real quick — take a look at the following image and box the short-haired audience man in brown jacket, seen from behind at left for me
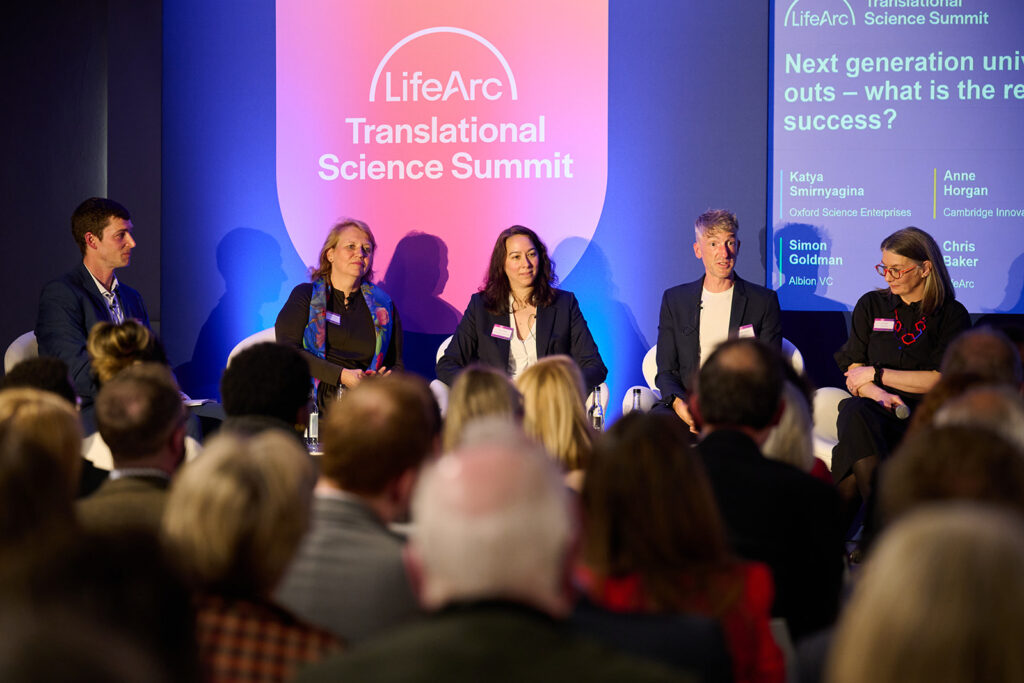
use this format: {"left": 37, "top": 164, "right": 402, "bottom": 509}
{"left": 77, "top": 362, "right": 185, "bottom": 533}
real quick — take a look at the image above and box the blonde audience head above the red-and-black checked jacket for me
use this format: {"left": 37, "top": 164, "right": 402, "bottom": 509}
{"left": 164, "top": 429, "right": 313, "bottom": 599}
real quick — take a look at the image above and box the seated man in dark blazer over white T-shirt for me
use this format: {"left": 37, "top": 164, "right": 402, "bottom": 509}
{"left": 654, "top": 209, "right": 782, "bottom": 429}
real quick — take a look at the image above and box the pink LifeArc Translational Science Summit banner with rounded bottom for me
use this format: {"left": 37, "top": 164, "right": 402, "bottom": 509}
{"left": 276, "top": 0, "right": 608, "bottom": 310}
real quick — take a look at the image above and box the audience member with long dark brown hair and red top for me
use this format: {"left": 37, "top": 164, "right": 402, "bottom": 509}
{"left": 577, "top": 411, "right": 785, "bottom": 683}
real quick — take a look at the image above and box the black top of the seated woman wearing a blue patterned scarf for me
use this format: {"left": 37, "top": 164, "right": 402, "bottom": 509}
{"left": 274, "top": 283, "right": 401, "bottom": 386}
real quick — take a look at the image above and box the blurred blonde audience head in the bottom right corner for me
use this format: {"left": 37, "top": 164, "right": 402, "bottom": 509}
{"left": 826, "top": 505, "right": 1024, "bottom": 683}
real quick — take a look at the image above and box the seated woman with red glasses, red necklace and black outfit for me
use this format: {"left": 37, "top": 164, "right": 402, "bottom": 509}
{"left": 831, "top": 227, "right": 971, "bottom": 532}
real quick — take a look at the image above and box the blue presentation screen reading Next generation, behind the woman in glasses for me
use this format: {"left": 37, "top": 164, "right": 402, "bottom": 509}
{"left": 766, "top": 0, "right": 1024, "bottom": 313}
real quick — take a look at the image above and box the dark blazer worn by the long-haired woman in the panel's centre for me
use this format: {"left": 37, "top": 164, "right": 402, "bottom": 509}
{"left": 437, "top": 290, "right": 608, "bottom": 389}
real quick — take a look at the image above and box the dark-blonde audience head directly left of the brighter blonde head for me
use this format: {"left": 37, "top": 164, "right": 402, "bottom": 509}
{"left": 442, "top": 364, "right": 523, "bottom": 451}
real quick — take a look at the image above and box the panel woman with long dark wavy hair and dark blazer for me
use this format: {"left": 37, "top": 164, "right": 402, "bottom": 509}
{"left": 437, "top": 225, "right": 608, "bottom": 389}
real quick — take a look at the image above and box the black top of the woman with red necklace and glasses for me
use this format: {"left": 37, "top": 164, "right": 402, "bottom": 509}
{"left": 836, "top": 290, "right": 971, "bottom": 401}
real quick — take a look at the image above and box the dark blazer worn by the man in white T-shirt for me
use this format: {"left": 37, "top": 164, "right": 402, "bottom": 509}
{"left": 654, "top": 276, "right": 782, "bottom": 405}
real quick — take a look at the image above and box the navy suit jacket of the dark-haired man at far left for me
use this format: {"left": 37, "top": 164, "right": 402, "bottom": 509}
{"left": 36, "top": 263, "right": 150, "bottom": 409}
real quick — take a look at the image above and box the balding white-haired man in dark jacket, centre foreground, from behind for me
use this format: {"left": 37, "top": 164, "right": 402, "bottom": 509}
{"left": 300, "top": 420, "right": 682, "bottom": 682}
